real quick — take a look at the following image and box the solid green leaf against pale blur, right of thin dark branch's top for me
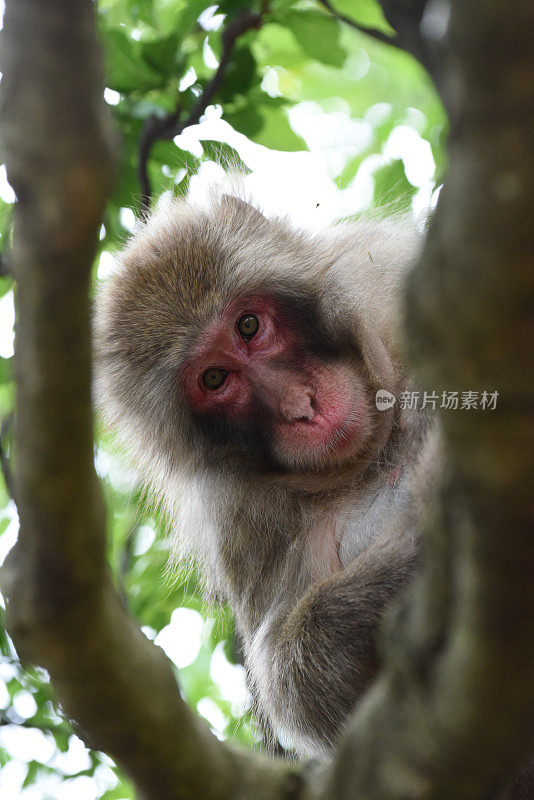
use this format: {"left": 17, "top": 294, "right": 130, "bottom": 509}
{"left": 282, "top": 10, "right": 347, "bottom": 67}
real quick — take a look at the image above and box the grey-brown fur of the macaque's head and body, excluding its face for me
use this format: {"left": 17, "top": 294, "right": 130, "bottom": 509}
{"left": 95, "top": 193, "right": 439, "bottom": 755}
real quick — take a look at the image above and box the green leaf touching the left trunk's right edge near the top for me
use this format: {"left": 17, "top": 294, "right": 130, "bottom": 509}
{"left": 102, "top": 28, "right": 164, "bottom": 93}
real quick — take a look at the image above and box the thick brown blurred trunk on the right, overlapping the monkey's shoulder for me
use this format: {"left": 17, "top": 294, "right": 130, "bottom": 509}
{"left": 322, "top": 0, "right": 534, "bottom": 800}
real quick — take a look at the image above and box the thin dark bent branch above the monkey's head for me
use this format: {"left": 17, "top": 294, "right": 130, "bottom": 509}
{"left": 138, "top": 9, "right": 262, "bottom": 213}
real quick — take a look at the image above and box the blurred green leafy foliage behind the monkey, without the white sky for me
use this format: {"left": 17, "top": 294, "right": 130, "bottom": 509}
{"left": 0, "top": 0, "right": 445, "bottom": 800}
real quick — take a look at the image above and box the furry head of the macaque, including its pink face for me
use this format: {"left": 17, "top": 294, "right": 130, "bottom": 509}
{"left": 95, "top": 196, "right": 406, "bottom": 489}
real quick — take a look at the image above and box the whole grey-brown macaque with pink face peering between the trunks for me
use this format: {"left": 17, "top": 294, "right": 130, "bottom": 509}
{"left": 95, "top": 192, "right": 439, "bottom": 756}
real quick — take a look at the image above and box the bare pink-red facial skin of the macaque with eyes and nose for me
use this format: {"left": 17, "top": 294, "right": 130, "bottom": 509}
{"left": 184, "top": 296, "right": 372, "bottom": 468}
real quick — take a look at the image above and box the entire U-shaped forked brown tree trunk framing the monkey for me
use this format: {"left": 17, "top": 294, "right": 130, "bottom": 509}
{"left": 1, "top": 0, "right": 534, "bottom": 800}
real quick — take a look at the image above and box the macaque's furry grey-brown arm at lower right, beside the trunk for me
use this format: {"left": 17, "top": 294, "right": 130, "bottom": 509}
{"left": 264, "top": 537, "right": 417, "bottom": 755}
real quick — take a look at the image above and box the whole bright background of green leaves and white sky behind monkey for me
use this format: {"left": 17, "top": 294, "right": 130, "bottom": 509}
{"left": 0, "top": 0, "right": 446, "bottom": 800}
